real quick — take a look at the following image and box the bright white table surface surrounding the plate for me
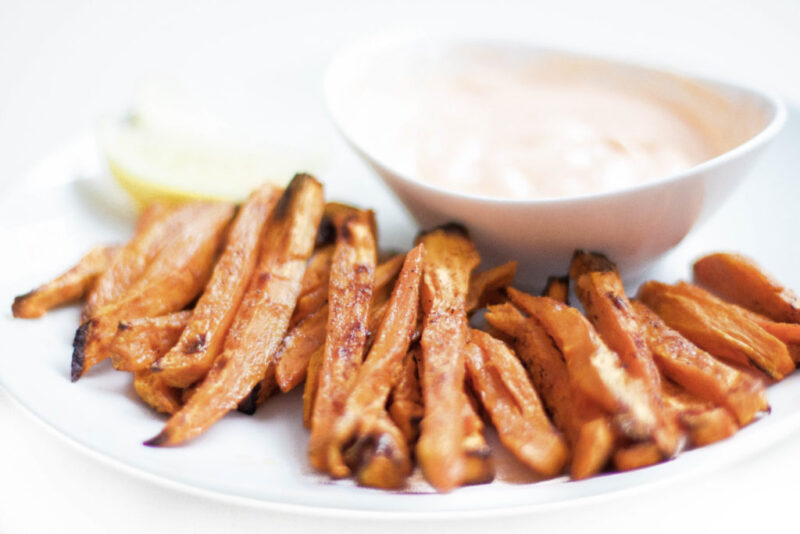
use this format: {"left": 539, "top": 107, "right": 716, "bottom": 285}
{"left": 0, "top": 0, "right": 800, "bottom": 534}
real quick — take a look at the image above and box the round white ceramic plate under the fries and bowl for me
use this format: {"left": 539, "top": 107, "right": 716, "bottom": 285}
{"left": 0, "top": 105, "right": 800, "bottom": 518}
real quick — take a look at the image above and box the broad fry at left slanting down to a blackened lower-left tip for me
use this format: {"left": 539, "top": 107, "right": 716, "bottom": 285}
{"left": 72, "top": 203, "right": 233, "bottom": 381}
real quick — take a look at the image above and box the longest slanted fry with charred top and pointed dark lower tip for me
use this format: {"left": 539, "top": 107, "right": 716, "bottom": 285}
{"left": 146, "top": 174, "right": 323, "bottom": 446}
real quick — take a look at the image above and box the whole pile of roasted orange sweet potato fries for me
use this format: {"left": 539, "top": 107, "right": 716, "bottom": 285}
{"left": 13, "top": 175, "right": 800, "bottom": 491}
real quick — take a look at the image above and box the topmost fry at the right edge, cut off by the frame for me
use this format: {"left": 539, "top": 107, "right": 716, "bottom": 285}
{"left": 694, "top": 253, "right": 800, "bottom": 323}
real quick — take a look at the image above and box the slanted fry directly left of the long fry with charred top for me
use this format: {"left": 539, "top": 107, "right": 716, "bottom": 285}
{"left": 153, "top": 185, "right": 281, "bottom": 388}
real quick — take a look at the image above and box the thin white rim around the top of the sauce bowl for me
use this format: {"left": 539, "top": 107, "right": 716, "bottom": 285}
{"left": 323, "top": 30, "right": 787, "bottom": 206}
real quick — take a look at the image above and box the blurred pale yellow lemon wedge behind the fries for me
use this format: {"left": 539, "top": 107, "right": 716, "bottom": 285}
{"left": 97, "top": 82, "right": 326, "bottom": 205}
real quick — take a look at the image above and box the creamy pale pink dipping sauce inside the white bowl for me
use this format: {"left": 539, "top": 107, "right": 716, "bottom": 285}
{"left": 346, "top": 49, "right": 722, "bottom": 198}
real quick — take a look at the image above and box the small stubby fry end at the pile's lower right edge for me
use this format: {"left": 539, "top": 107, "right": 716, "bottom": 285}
{"left": 664, "top": 381, "right": 739, "bottom": 447}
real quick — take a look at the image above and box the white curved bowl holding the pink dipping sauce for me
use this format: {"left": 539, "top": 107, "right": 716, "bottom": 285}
{"left": 325, "top": 34, "right": 786, "bottom": 286}
